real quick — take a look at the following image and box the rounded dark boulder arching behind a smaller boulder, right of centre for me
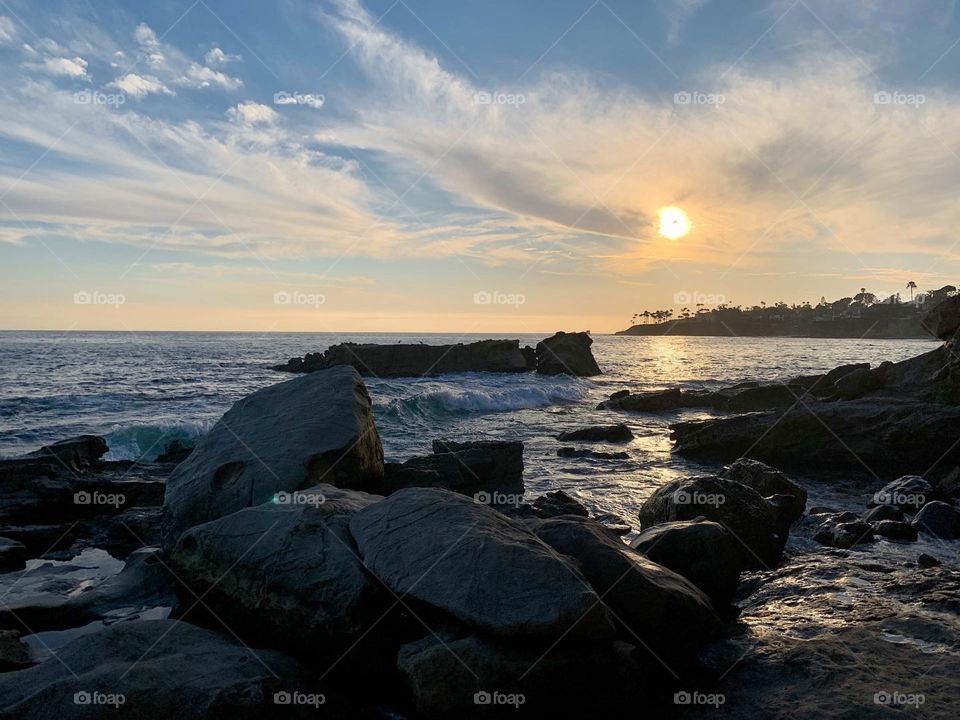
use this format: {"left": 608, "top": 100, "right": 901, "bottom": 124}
{"left": 639, "top": 476, "right": 787, "bottom": 569}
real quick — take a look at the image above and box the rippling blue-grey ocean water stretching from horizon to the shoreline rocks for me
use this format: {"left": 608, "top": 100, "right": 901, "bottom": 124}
{"left": 0, "top": 332, "right": 936, "bottom": 520}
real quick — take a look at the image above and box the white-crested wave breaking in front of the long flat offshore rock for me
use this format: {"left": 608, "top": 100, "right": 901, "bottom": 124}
{"left": 384, "top": 385, "right": 586, "bottom": 417}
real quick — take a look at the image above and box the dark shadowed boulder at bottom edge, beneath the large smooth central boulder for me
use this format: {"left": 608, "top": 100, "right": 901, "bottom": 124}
{"left": 397, "top": 635, "right": 647, "bottom": 720}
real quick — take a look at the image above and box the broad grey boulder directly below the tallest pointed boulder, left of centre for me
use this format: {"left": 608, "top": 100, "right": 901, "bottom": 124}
{"left": 171, "top": 485, "right": 390, "bottom": 666}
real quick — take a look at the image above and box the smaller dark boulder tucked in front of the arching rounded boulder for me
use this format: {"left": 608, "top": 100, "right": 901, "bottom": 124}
{"left": 630, "top": 520, "right": 740, "bottom": 613}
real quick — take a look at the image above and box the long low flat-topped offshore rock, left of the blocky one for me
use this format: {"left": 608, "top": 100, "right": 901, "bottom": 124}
{"left": 273, "top": 340, "right": 528, "bottom": 377}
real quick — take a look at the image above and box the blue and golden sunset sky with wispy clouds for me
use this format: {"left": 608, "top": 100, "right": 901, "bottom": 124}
{"left": 0, "top": 0, "right": 960, "bottom": 334}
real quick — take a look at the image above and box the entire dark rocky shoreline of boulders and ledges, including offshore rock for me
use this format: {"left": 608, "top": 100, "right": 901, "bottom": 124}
{"left": 0, "top": 304, "right": 960, "bottom": 719}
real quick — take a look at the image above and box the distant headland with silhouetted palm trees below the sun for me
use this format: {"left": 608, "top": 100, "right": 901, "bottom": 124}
{"left": 616, "top": 281, "right": 957, "bottom": 338}
